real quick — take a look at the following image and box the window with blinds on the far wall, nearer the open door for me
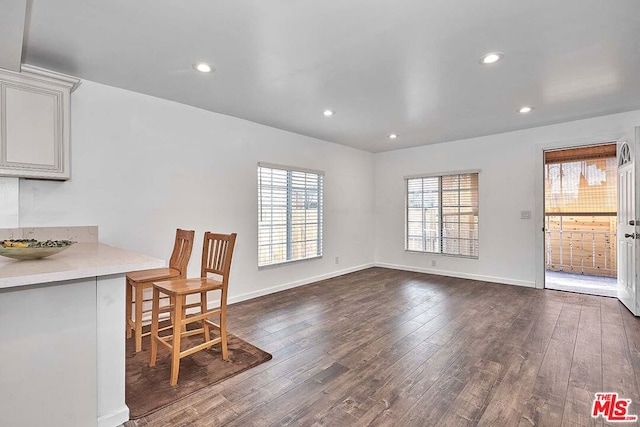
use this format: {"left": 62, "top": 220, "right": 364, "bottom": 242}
{"left": 405, "top": 173, "right": 478, "bottom": 258}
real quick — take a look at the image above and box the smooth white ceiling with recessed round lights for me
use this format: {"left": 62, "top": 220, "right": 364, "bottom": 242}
{"left": 13, "top": 0, "right": 640, "bottom": 152}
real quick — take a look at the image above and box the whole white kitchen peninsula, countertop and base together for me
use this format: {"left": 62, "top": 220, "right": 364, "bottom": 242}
{"left": 0, "top": 242, "right": 166, "bottom": 427}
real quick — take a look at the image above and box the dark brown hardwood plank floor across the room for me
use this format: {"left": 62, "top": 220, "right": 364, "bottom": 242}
{"left": 126, "top": 268, "right": 640, "bottom": 427}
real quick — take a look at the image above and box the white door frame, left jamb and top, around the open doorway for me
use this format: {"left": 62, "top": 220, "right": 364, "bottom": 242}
{"left": 533, "top": 132, "right": 629, "bottom": 289}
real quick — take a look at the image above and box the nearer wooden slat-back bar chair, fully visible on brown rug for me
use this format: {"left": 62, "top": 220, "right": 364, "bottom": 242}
{"left": 149, "top": 231, "right": 236, "bottom": 385}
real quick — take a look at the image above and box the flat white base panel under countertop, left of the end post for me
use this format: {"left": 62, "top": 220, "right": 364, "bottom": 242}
{"left": 0, "top": 277, "right": 98, "bottom": 427}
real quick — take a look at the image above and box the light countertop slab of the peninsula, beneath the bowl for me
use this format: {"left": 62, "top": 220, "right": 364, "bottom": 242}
{"left": 0, "top": 243, "right": 166, "bottom": 289}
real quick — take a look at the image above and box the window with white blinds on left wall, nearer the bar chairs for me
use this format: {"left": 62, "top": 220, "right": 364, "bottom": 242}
{"left": 258, "top": 163, "right": 324, "bottom": 267}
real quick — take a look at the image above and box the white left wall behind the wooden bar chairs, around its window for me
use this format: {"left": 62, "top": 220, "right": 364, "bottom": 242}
{"left": 19, "top": 81, "right": 374, "bottom": 301}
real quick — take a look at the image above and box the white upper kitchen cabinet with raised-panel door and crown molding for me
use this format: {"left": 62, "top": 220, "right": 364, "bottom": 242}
{"left": 0, "top": 65, "right": 79, "bottom": 179}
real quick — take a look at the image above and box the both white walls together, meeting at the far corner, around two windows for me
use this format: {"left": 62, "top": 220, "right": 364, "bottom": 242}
{"left": 8, "top": 77, "right": 640, "bottom": 301}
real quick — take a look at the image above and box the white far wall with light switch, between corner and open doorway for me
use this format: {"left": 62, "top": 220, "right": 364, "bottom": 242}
{"left": 375, "top": 111, "right": 640, "bottom": 286}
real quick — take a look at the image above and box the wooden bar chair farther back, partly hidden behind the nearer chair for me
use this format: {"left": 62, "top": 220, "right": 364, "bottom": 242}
{"left": 125, "top": 228, "right": 195, "bottom": 352}
